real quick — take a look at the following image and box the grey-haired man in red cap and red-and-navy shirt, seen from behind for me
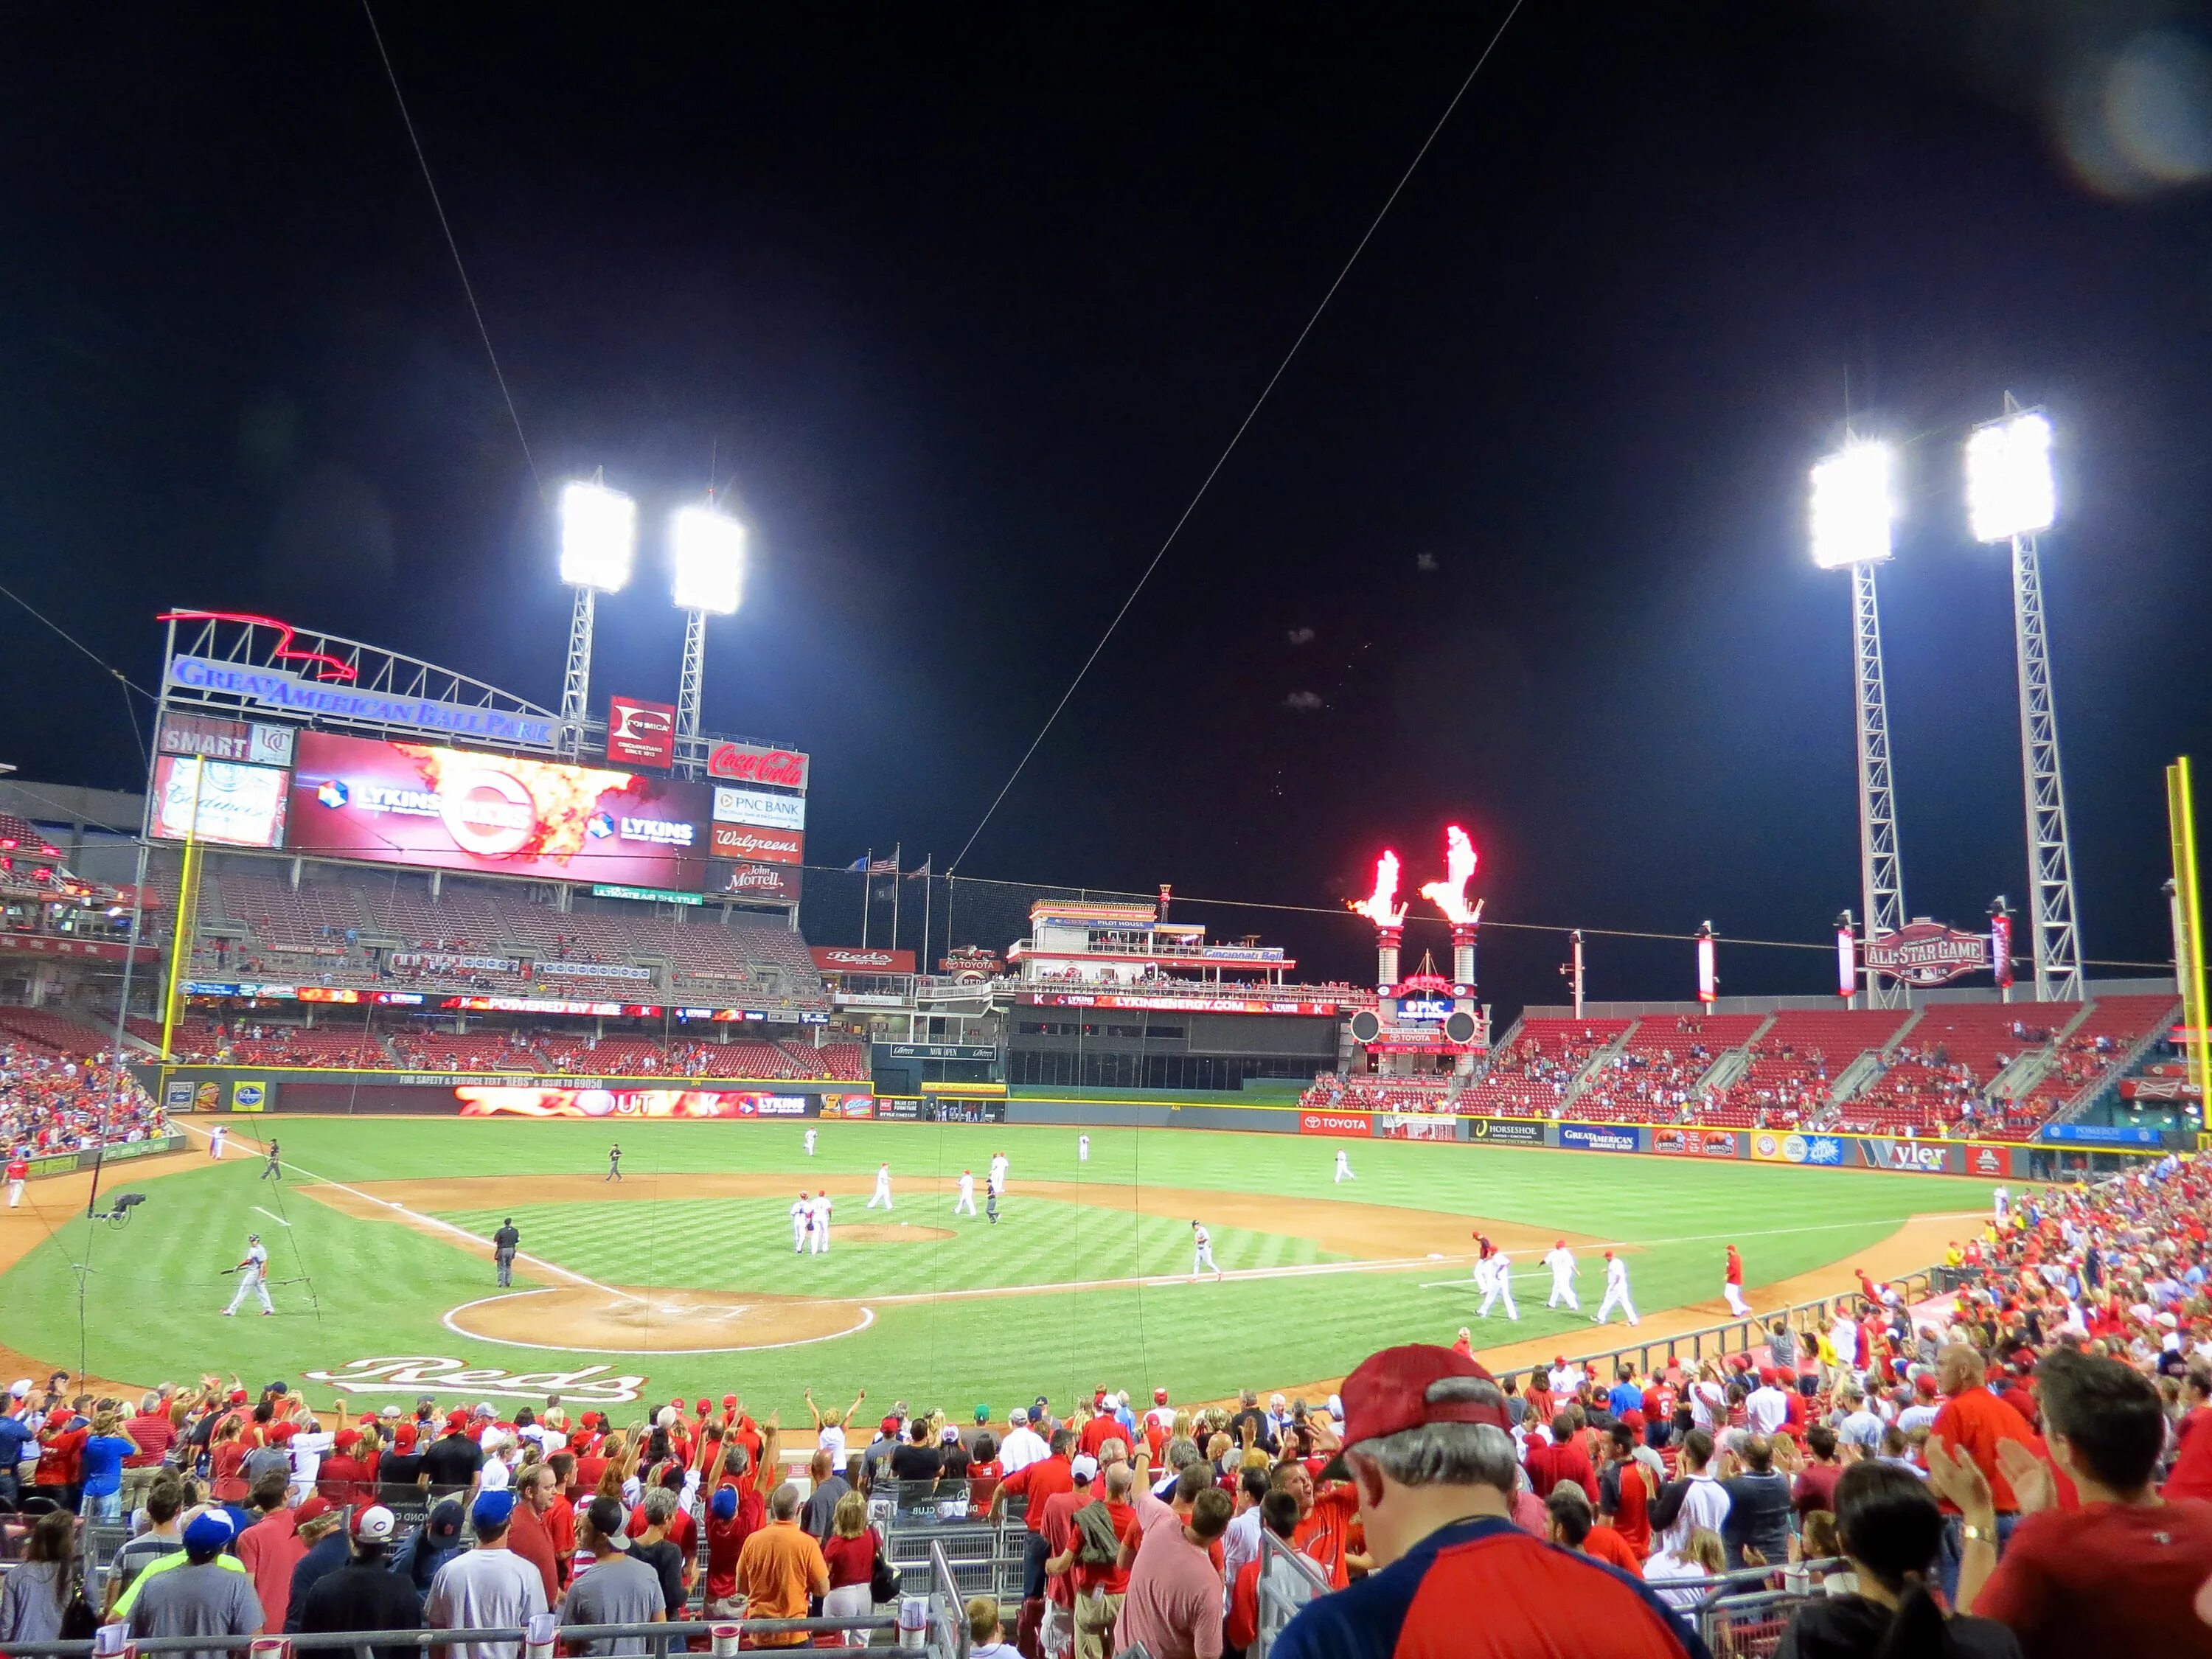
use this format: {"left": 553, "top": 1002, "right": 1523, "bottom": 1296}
{"left": 1274, "top": 1343, "right": 1710, "bottom": 1659}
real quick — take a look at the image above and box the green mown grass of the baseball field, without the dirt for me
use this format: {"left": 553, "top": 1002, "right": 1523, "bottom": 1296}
{"left": 0, "top": 1119, "right": 1989, "bottom": 1418}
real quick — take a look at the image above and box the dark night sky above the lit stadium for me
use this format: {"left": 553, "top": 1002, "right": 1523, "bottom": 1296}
{"left": 0, "top": 0, "right": 2212, "bottom": 1006}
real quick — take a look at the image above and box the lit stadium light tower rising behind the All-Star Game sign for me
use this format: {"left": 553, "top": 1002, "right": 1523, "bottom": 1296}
{"left": 1812, "top": 438, "right": 1905, "bottom": 1009}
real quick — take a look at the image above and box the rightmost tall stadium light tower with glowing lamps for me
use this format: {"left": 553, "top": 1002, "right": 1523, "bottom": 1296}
{"left": 1966, "top": 394, "right": 2081, "bottom": 1002}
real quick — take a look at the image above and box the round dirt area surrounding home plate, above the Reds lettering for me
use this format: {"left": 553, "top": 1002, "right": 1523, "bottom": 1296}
{"left": 445, "top": 1285, "right": 876, "bottom": 1354}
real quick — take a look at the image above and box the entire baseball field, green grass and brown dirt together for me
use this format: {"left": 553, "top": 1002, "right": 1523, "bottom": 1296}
{"left": 0, "top": 1117, "right": 1989, "bottom": 1422}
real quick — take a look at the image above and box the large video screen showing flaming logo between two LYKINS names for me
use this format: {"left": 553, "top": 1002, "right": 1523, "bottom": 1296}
{"left": 290, "top": 732, "right": 708, "bottom": 889}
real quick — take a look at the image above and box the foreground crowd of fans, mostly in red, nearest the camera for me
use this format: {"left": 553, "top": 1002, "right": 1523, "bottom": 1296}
{"left": 13, "top": 1159, "right": 2212, "bottom": 1659}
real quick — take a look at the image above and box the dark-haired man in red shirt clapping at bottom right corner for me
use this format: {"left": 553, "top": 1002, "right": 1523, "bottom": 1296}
{"left": 1929, "top": 1349, "right": 2212, "bottom": 1659}
